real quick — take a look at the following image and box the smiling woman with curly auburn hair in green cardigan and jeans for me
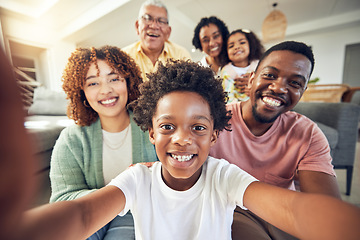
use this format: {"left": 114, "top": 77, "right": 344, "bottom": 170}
{"left": 50, "top": 46, "right": 156, "bottom": 239}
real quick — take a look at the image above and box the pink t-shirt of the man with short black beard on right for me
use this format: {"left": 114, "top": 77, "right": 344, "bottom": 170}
{"left": 210, "top": 103, "right": 335, "bottom": 189}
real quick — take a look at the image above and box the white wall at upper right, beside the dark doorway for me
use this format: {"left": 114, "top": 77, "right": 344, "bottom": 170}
{"left": 266, "top": 23, "right": 360, "bottom": 85}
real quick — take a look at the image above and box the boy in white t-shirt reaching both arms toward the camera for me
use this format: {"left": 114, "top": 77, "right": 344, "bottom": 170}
{"left": 22, "top": 61, "right": 360, "bottom": 239}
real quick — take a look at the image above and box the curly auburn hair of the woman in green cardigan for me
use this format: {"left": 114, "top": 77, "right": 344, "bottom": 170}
{"left": 62, "top": 46, "right": 143, "bottom": 126}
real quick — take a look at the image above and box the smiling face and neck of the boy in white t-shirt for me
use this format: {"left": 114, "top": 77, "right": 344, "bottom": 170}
{"left": 149, "top": 91, "right": 218, "bottom": 191}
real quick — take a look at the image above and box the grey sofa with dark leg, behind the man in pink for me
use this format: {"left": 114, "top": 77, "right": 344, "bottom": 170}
{"left": 293, "top": 102, "right": 360, "bottom": 195}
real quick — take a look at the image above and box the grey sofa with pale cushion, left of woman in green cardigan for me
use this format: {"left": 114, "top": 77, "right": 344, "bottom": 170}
{"left": 24, "top": 87, "right": 74, "bottom": 206}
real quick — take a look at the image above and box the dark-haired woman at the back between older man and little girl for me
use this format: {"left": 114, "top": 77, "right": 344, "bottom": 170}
{"left": 192, "top": 16, "right": 229, "bottom": 75}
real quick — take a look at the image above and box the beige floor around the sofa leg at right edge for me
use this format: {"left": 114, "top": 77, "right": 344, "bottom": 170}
{"left": 335, "top": 137, "right": 360, "bottom": 207}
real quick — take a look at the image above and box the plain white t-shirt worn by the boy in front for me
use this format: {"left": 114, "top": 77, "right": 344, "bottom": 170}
{"left": 109, "top": 157, "right": 256, "bottom": 240}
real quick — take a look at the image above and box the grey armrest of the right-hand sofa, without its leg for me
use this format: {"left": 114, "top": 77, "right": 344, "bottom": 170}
{"left": 294, "top": 102, "right": 360, "bottom": 166}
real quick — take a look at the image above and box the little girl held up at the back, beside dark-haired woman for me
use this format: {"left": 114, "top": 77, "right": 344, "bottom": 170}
{"left": 221, "top": 29, "right": 264, "bottom": 103}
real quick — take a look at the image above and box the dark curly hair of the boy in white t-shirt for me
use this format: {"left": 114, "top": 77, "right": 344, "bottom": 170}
{"left": 131, "top": 60, "right": 231, "bottom": 131}
